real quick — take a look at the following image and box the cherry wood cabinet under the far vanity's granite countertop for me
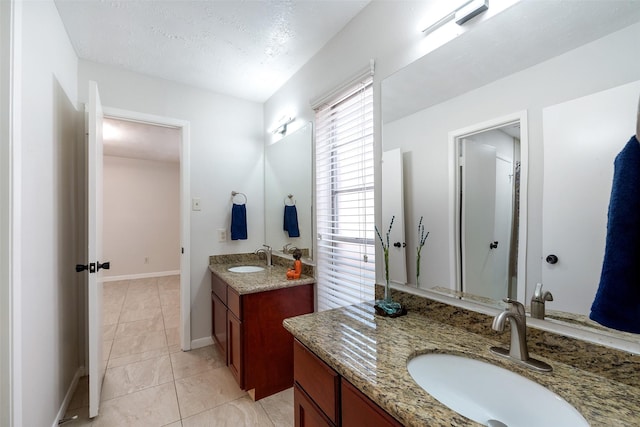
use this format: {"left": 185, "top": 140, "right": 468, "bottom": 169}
{"left": 211, "top": 272, "right": 314, "bottom": 400}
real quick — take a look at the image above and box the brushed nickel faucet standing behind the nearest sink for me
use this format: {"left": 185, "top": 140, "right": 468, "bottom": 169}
{"left": 490, "top": 298, "right": 551, "bottom": 372}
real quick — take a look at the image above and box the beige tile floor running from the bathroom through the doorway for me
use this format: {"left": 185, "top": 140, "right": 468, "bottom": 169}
{"left": 64, "top": 276, "right": 293, "bottom": 427}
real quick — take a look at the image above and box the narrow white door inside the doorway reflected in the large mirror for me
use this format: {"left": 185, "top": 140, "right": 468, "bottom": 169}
{"left": 460, "top": 139, "right": 500, "bottom": 299}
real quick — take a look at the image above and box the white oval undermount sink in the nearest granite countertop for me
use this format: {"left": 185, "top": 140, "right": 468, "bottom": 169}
{"left": 407, "top": 353, "right": 589, "bottom": 427}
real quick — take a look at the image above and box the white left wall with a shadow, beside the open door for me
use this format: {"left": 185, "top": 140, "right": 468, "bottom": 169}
{"left": 19, "top": 1, "right": 82, "bottom": 426}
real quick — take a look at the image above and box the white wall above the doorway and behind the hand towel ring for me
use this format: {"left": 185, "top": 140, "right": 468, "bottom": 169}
{"left": 78, "top": 60, "right": 264, "bottom": 340}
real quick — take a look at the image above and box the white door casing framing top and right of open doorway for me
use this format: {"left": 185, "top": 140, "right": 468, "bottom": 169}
{"left": 103, "top": 107, "right": 192, "bottom": 351}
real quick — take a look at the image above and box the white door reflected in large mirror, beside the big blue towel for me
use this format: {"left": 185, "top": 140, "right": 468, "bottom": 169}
{"left": 541, "top": 81, "right": 640, "bottom": 315}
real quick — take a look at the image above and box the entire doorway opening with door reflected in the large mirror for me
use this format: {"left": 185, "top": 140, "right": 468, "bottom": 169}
{"left": 458, "top": 124, "right": 520, "bottom": 300}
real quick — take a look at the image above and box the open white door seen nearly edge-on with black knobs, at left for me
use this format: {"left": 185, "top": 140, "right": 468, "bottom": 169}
{"left": 87, "top": 82, "right": 109, "bottom": 418}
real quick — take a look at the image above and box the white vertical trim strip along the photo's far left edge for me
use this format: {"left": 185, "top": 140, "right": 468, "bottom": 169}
{"left": 0, "top": 0, "right": 22, "bottom": 427}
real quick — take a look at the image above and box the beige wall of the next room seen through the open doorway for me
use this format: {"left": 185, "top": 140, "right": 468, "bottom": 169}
{"left": 103, "top": 155, "right": 180, "bottom": 277}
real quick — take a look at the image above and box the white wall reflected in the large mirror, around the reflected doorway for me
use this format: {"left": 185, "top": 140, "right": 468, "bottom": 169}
{"left": 384, "top": 20, "right": 640, "bottom": 300}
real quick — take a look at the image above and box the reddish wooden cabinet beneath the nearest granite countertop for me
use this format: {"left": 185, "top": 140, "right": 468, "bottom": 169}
{"left": 293, "top": 340, "right": 402, "bottom": 427}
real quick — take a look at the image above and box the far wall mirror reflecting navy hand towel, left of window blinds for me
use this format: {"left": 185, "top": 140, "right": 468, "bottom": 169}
{"left": 264, "top": 122, "right": 313, "bottom": 257}
